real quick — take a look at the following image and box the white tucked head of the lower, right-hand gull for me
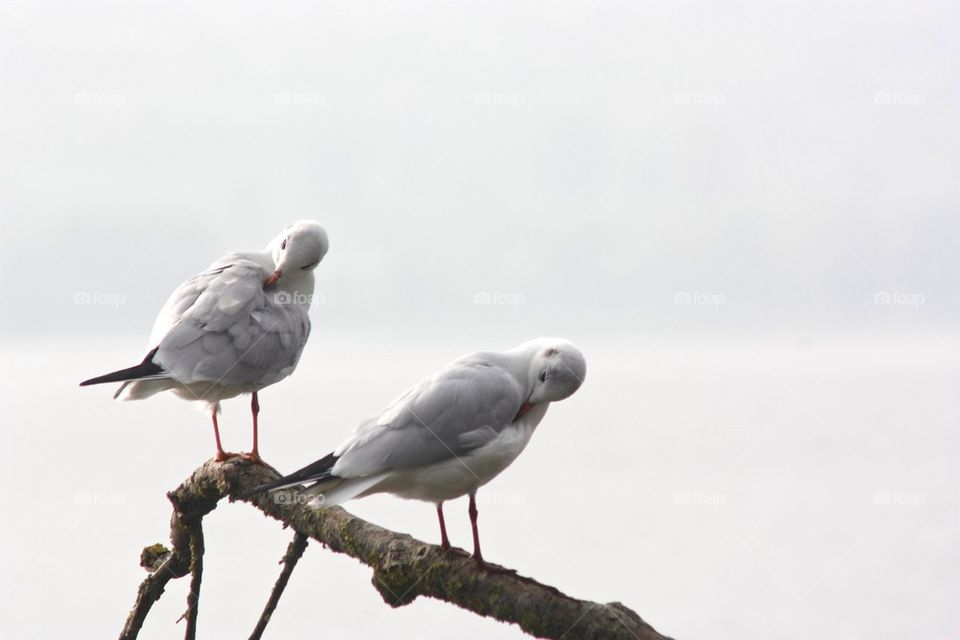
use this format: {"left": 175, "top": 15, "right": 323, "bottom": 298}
{"left": 524, "top": 338, "right": 587, "bottom": 404}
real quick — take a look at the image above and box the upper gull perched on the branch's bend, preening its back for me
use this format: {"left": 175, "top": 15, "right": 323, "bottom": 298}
{"left": 80, "top": 220, "right": 329, "bottom": 462}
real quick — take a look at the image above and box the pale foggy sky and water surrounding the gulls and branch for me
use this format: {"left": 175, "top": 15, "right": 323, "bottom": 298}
{"left": 0, "top": 1, "right": 960, "bottom": 639}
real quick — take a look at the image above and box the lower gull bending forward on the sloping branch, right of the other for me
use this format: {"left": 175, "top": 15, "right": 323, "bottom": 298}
{"left": 249, "top": 338, "right": 586, "bottom": 566}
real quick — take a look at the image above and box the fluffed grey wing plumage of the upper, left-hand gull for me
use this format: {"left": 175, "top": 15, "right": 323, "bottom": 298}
{"left": 151, "top": 254, "right": 310, "bottom": 388}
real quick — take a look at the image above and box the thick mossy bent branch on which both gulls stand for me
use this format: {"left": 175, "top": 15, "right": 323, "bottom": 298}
{"left": 120, "top": 459, "right": 668, "bottom": 640}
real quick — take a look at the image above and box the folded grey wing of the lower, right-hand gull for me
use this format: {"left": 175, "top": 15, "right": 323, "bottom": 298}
{"left": 333, "top": 362, "right": 525, "bottom": 477}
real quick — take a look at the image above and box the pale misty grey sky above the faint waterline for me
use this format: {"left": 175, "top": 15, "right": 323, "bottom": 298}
{"left": 0, "top": 2, "right": 960, "bottom": 344}
